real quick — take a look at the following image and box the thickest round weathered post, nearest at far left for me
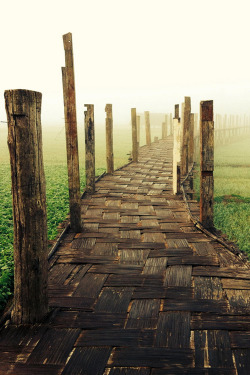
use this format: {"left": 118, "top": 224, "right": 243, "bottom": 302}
{"left": 5, "top": 90, "right": 48, "bottom": 324}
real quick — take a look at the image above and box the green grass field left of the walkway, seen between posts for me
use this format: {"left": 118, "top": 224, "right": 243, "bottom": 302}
{"left": 0, "top": 126, "right": 131, "bottom": 311}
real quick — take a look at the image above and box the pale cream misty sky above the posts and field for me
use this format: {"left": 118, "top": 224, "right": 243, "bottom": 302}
{"left": 0, "top": 0, "right": 250, "bottom": 126}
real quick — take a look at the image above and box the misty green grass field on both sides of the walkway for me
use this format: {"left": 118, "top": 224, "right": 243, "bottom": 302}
{"left": 0, "top": 124, "right": 250, "bottom": 310}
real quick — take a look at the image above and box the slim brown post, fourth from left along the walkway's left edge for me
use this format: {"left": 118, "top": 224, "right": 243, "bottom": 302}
{"left": 105, "top": 104, "right": 114, "bottom": 174}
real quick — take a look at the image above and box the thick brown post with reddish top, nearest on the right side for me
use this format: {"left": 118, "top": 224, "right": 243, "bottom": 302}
{"left": 200, "top": 100, "right": 214, "bottom": 229}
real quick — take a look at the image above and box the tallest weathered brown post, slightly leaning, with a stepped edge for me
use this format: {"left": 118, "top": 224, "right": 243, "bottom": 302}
{"left": 62, "top": 33, "right": 82, "bottom": 232}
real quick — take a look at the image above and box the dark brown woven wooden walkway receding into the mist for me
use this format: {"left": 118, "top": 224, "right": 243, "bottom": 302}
{"left": 0, "top": 139, "right": 250, "bottom": 375}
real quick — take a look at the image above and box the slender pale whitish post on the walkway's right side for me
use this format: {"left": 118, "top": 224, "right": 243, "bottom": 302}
{"left": 173, "top": 104, "right": 181, "bottom": 194}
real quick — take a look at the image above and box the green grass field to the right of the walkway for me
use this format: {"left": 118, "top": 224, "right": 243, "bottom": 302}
{"left": 195, "top": 138, "right": 250, "bottom": 258}
